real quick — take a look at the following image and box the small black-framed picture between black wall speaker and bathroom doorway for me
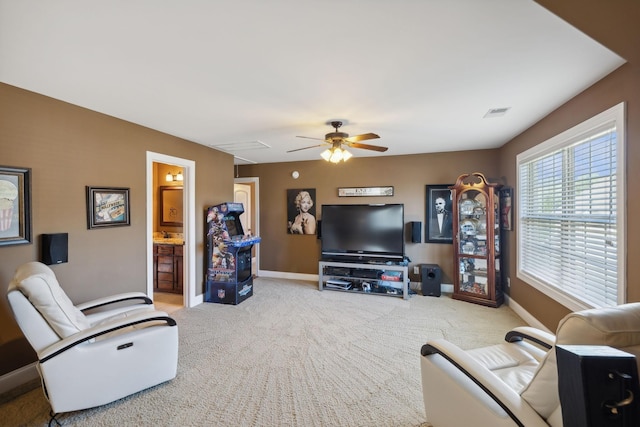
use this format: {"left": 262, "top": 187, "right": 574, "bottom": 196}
{"left": 87, "top": 187, "right": 131, "bottom": 229}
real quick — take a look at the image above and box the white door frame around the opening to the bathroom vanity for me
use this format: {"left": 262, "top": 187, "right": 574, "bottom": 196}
{"left": 146, "top": 151, "right": 203, "bottom": 307}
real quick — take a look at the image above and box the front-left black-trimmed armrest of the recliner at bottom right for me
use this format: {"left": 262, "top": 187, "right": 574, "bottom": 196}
{"left": 420, "top": 339, "right": 547, "bottom": 427}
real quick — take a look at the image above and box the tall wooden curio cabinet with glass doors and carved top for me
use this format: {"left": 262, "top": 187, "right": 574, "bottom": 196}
{"left": 451, "top": 172, "right": 504, "bottom": 307}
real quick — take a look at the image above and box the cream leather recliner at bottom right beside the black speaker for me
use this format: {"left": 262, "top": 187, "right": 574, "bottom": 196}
{"left": 421, "top": 303, "right": 640, "bottom": 427}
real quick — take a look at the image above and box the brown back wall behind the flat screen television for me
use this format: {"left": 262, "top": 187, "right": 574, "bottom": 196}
{"left": 239, "top": 150, "right": 501, "bottom": 283}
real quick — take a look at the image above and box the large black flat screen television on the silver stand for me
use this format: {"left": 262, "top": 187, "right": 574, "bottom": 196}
{"left": 320, "top": 204, "right": 404, "bottom": 262}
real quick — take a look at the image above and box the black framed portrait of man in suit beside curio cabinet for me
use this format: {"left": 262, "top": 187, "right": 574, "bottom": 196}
{"left": 425, "top": 184, "right": 453, "bottom": 243}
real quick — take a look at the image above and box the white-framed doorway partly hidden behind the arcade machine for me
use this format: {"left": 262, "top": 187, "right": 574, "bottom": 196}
{"left": 233, "top": 177, "right": 260, "bottom": 276}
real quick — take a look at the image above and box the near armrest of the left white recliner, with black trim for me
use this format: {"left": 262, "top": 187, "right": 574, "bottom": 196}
{"left": 38, "top": 311, "right": 177, "bottom": 363}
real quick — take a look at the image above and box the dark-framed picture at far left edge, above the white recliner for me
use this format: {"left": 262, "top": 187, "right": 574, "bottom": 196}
{"left": 0, "top": 166, "right": 31, "bottom": 246}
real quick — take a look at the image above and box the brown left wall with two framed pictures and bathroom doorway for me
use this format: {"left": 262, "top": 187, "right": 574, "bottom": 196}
{"left": 0, "top": 84, "right": 233, "bottom": 375}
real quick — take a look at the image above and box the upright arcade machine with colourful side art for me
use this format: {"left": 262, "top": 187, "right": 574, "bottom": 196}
{"left": 204, "top": 202, "right": 260, "bottom": 305}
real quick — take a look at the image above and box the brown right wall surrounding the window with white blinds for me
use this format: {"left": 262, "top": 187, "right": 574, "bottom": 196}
{"left": 490, "top": 0, "right": 640, "bottom": 330}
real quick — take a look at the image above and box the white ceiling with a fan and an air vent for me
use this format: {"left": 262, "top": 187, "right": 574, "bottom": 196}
{"left": 0, "top": 0, "right": 624, "bottom": 164}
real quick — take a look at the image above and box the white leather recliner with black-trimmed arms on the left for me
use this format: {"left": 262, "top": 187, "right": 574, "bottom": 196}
{"left": 7, "top": 262, "right": 178, "bottom": 418}
